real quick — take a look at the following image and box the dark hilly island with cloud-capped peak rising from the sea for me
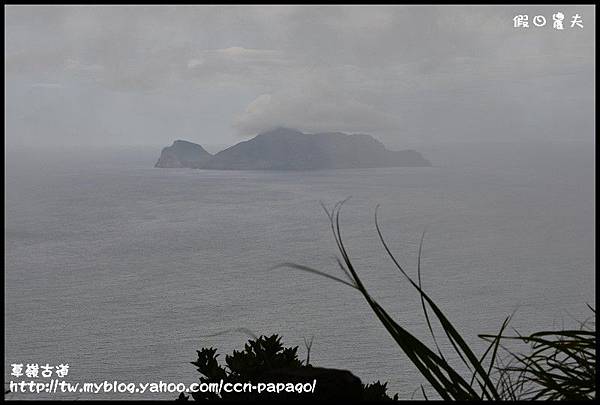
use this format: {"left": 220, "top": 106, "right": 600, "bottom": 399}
{"left": 156, "top": 128, "right": 431, "bottom": 170}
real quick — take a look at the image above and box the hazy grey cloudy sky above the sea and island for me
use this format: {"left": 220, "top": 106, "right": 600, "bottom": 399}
{"left": 5, "top": 5, "right": 595, "bottom": 146}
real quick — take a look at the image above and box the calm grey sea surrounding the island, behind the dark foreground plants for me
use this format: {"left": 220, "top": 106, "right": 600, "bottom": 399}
{"left": 4, "top": 143, "right": 596, "bottom": 399}
